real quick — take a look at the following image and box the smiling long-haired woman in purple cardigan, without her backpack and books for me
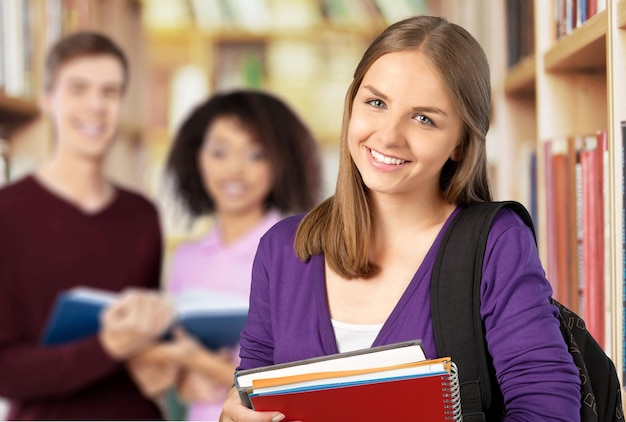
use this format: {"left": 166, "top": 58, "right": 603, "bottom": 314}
{"left": 221, "top": 16, "right": 580, "bottom": 422}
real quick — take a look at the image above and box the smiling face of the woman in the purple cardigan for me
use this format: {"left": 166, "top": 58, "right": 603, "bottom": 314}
{"left": 347, "top": 51, "right": 462, "bottom": 201}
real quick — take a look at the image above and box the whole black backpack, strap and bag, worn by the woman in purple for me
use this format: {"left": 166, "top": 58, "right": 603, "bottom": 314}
{"left": 431, "top": 201, "right": 624, "bottom": 422}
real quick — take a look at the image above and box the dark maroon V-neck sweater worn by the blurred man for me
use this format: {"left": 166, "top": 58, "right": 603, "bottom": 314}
{"left": 0, "top": 176, "right": 162, "bottom": 420}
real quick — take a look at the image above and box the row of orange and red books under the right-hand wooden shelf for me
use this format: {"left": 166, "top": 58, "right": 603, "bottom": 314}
{"left": 544, "top": 130, "right": 610, "bottom": 347}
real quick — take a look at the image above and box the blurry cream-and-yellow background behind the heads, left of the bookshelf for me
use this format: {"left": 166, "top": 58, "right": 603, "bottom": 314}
{"left": 0, "top": 0, "right": 504, "bottom": 250}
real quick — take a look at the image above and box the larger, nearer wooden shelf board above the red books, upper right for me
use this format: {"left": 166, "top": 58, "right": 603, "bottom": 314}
{"left": 544, "top": 9, "right": 604, "bottom": 72}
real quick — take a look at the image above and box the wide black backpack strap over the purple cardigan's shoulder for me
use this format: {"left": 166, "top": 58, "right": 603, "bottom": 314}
{"left": 430, "top": 201, "right": 534, "bottom": 421}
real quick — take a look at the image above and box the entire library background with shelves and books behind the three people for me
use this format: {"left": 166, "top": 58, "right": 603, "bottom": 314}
{"left": 0, "top": 0, "right": 626, "bottom": 413}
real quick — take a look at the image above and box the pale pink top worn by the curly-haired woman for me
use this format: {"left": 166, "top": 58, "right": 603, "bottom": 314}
{"left": 167, "top": 210, "right": 282, "bottom": 421}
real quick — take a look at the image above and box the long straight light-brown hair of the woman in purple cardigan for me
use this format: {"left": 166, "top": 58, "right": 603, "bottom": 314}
{"left": 294, "top": 16, "right": 491, "bottom": 278}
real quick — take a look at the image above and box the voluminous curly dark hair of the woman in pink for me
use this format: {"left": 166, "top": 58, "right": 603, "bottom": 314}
{"left": 165, "top": 90, "right": 322, "bottom": 218}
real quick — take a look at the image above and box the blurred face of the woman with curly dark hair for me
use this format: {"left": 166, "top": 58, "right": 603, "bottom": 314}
{"left": 198, "top": 116, "right": 273, "bottom": 216}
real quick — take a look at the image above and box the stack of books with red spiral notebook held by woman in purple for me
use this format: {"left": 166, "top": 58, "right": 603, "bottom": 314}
{"left": 235, "top": 340, "right": 461, "bottom": 422}
